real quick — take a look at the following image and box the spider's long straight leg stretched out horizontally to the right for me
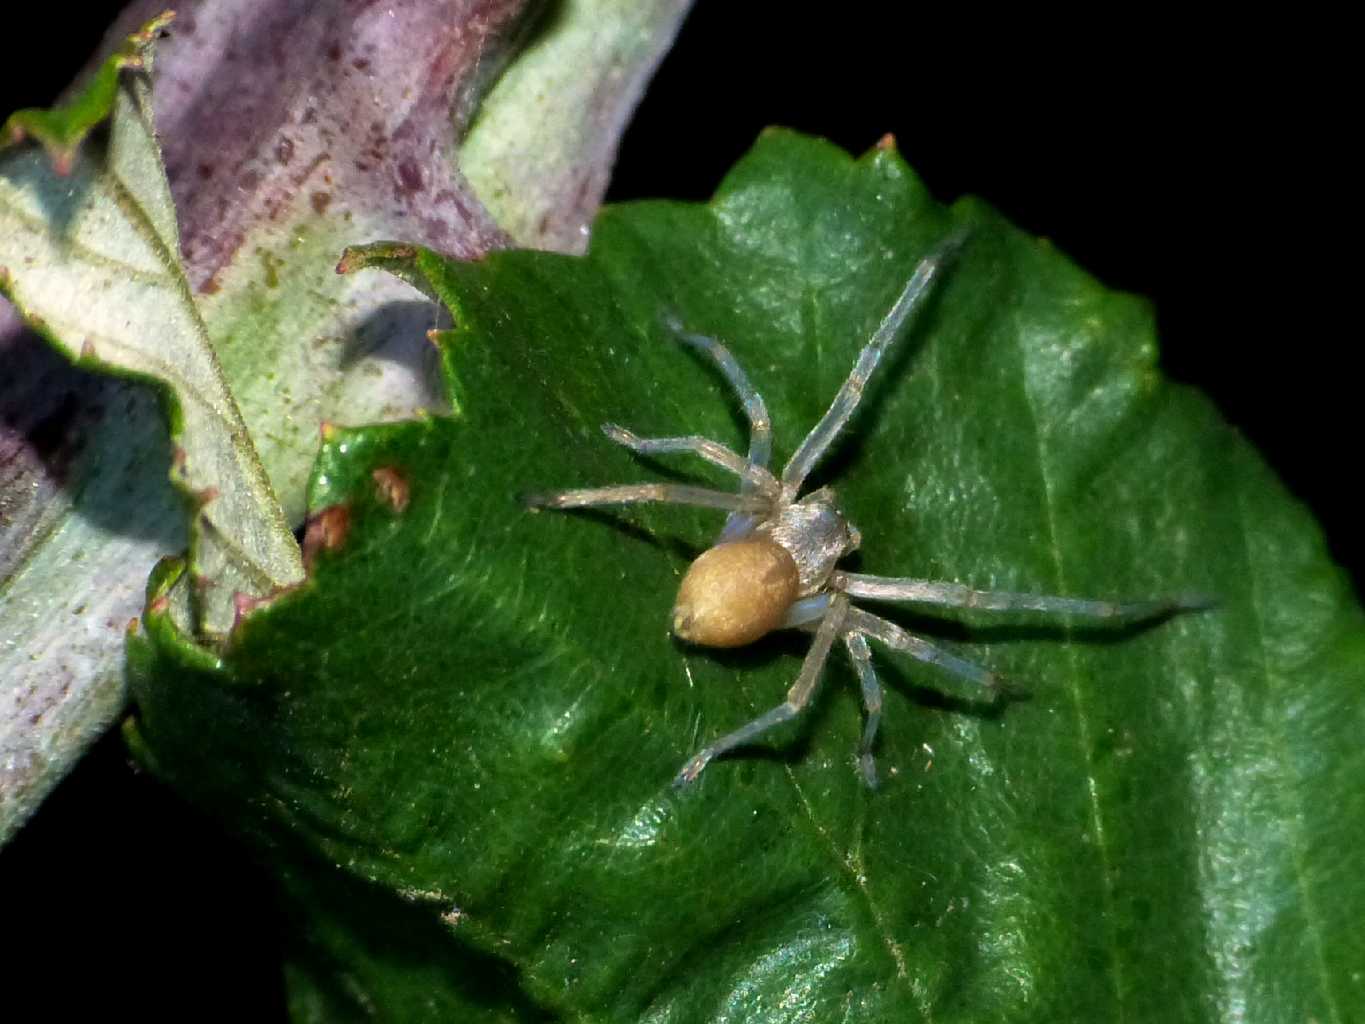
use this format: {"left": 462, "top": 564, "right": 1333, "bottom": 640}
{"left": 830, "top": 572, "right": 1212, "bottom": 624}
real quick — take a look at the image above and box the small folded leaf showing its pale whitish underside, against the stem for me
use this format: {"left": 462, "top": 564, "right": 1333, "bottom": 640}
{"left": 0, "top": 15, "right": 303, "bottom": 638}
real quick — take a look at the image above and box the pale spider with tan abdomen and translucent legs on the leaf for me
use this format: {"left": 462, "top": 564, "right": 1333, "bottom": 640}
{"left": 524, "top": 235, "right": 1207, "bottom": 788}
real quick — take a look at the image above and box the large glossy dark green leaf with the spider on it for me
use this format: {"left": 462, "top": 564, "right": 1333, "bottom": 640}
{"left": 131, "top": 132, "right": 1365, "bottom": 1024}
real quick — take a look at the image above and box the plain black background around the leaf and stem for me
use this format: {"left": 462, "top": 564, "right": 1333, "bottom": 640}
{"left": 0, "top": 0, "right": 1343, "bottom": 1020}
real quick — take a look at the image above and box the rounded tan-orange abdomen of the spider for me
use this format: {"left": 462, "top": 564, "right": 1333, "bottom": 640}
{"left": 673, "top": 537, "right": 801, "bottom": 647}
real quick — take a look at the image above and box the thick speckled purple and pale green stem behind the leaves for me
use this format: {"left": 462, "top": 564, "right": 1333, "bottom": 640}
{"left": 0, "top": 0, "right": 685, "bottom": 842}
